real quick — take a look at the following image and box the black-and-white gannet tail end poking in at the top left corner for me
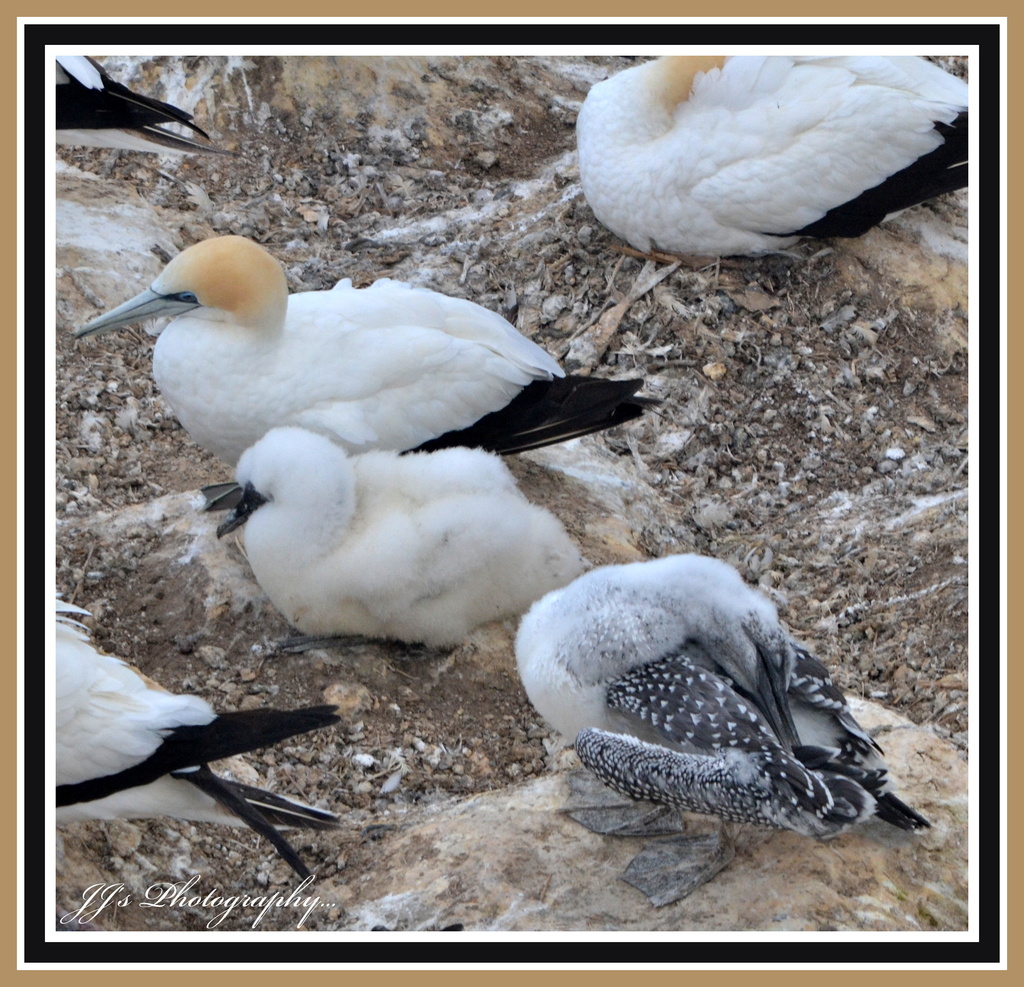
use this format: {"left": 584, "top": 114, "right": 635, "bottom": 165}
{"left": 56, "top": 55, "right": 230, "bottom": 155}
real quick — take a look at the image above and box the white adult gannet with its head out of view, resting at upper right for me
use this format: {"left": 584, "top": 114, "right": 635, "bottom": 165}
{"left": 577, "top": 55, "right": 968, "bottom": 255}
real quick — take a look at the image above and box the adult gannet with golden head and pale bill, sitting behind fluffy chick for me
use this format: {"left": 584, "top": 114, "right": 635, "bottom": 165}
{"left": 76, "top": 237, "right": 649, "bottom": 464}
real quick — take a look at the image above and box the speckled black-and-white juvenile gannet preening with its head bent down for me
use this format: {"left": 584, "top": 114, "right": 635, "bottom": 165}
{"left": 516, "top": 555, "right": 929, "bottom": 838}
